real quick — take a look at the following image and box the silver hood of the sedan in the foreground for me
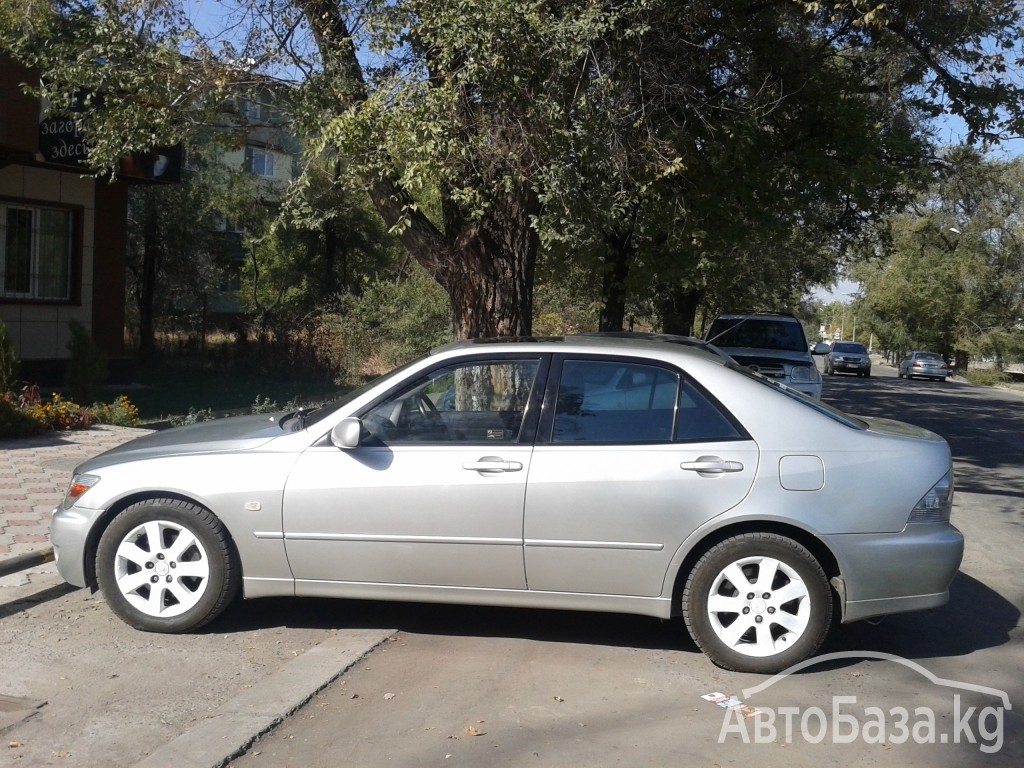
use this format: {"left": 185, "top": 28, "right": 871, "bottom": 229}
{"left": 75, "top": 414, "right": 283, "bottom": 473}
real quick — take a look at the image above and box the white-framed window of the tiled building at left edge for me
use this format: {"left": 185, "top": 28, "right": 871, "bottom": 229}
{"left": 0, "top": 202, "right": 74, "bottom": 301}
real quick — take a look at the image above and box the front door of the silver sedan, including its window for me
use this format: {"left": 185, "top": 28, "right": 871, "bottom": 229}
{"left": 284, "top": 355, "right": 546, "bottom": 592}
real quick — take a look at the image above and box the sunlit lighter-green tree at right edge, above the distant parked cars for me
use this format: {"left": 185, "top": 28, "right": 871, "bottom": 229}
{"left": 854, "top": 147, "right": 1024, "bottom": 367}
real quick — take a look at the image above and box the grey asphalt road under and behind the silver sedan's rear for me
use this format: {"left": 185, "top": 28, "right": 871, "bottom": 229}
{"left": 231, "top": 367, "right": 1024, "bottom": 768}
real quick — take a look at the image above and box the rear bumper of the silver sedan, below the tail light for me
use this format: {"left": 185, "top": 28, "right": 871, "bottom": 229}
{"left": 821, "top": 523, "right": 964, "bottom": 624}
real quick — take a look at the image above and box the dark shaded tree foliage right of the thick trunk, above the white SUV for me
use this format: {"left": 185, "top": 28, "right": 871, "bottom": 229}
{"left": 542, "top": 0, "right": 1021, "bottom": 333}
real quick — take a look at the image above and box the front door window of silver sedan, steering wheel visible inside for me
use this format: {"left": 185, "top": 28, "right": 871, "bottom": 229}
{"left": 362, "top": 359, "right": 540, "bottom": 445}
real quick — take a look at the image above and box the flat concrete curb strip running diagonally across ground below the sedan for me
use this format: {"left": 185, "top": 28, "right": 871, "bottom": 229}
{"left": 134, "top": 630, "right": 397, "bottom": 768}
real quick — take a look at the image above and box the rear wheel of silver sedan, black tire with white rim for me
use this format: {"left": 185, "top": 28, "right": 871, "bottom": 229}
{"left": 682, "top": 532, "right": 833, "bottom": 675}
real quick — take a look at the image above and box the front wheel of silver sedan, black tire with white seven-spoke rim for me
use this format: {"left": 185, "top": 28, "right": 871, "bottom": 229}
{"left": 96, "top": 499, "right": 242, "bottom": 634}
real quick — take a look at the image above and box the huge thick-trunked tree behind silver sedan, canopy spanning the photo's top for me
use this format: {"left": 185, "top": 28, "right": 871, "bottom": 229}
{"left": 0, "top": 0, "right": 1021, "bottom": 337}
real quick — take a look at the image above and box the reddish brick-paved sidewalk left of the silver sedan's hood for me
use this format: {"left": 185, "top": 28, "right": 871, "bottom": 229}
{"left": 0, "top": 425, "right": 151, "bottom": 560}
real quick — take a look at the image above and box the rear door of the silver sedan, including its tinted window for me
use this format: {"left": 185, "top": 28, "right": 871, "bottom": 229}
{"left": 523, "top": 356, "right": 758, "bottom": 597}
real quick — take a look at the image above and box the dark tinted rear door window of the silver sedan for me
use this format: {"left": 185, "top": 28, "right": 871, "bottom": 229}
{"left": 552, "top": 360, "right": 742, "bottom": 443}
